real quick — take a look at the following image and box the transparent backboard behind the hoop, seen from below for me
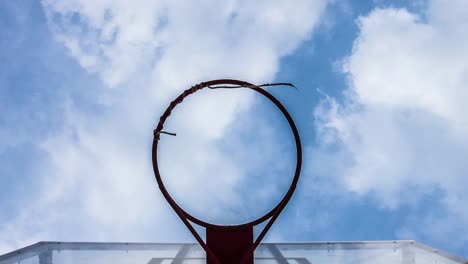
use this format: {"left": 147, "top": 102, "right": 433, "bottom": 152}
{"left": 0, "top": 241, "right": 468, "bottom": 264}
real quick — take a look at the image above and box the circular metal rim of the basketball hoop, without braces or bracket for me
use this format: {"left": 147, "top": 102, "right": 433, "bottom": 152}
{"left": 152, "top": 79, "right": 302, "bottom": 230}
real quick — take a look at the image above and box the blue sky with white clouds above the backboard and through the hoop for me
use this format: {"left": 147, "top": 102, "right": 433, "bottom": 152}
{"left": 0, "top": 0, "right": 468, "bottom": 257}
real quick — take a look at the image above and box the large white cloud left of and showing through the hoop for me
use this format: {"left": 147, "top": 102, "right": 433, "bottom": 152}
{"left": 0, "top": 0, "right": 326, "bottom": 254}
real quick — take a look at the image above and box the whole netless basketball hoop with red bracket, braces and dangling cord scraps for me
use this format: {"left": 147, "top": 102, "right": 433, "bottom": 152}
{"left": 152, "top": 79, "right": 302, "bottom": 264}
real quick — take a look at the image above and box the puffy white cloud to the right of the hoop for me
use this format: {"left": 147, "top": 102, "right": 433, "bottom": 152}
{"left": 315, "top": 0, "right": 468, "bottom": 246}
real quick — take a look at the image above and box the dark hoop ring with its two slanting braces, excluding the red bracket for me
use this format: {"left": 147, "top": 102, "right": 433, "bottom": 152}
{"left": 152, "top": 79, "right": 302, "bottom": 263}
